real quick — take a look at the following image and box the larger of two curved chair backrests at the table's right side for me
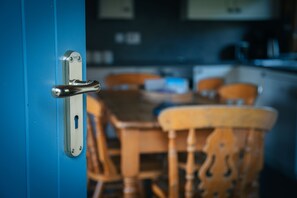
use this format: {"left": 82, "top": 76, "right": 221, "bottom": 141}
{"left": 218, "top": 83, "right": 259, "bottom": 105}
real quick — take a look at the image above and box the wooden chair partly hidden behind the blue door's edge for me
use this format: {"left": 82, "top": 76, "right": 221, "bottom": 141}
{"left": 87, "top": 95, "right": 163, "bottom": 197}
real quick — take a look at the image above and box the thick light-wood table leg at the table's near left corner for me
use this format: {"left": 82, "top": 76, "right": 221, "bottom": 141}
{"left": 121, "top": 129, "right": 140, "bottom": 198}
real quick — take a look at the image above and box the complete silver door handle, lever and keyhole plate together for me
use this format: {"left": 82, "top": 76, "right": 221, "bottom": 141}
{"left": 52, "top": 51, "right": 100, "bottom": 157}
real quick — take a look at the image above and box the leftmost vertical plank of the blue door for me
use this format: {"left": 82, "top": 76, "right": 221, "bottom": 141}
{"left": 0, "top": 1, "right": 27, "bottom": 197}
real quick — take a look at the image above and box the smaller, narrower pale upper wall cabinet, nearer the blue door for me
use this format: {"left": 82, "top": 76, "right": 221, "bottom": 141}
{"left": 98, "top": 0, "right": 134, "bottom": 19}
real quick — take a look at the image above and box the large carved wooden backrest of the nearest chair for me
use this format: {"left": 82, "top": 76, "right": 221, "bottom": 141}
{"left": 158, "top": 105, "right": 277, "bottom": 197}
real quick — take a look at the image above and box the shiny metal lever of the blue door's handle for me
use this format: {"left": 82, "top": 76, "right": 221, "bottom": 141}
{"left": 52, "top": 80, "right": 100, "bottom": 98}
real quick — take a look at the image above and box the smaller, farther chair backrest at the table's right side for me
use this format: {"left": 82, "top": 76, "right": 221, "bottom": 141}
{"left": 197, "top": 77, "right": 225, "bottom": 92}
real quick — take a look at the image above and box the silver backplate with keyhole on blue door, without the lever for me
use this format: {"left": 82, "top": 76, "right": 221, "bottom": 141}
{"left": 63, "top": 51, "right": 84, "bottom": 157}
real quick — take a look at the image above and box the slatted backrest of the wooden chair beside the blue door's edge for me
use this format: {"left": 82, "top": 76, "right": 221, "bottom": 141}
{"left": 87, "top": 95, "right": 117, "bottom": 176}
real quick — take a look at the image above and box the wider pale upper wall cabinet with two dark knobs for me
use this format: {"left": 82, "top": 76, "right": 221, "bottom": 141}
{"left": 182, "top": 0, "right": 279, "bottom": 20}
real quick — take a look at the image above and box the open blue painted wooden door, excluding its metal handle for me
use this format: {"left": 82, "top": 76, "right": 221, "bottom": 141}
{"left": 0, "top": 0, "right": 87, "bottom": 198}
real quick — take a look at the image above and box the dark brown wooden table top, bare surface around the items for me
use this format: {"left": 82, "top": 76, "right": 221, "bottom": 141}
{"left": 97, "top": 90, "right": 218, "bottom": 129}
